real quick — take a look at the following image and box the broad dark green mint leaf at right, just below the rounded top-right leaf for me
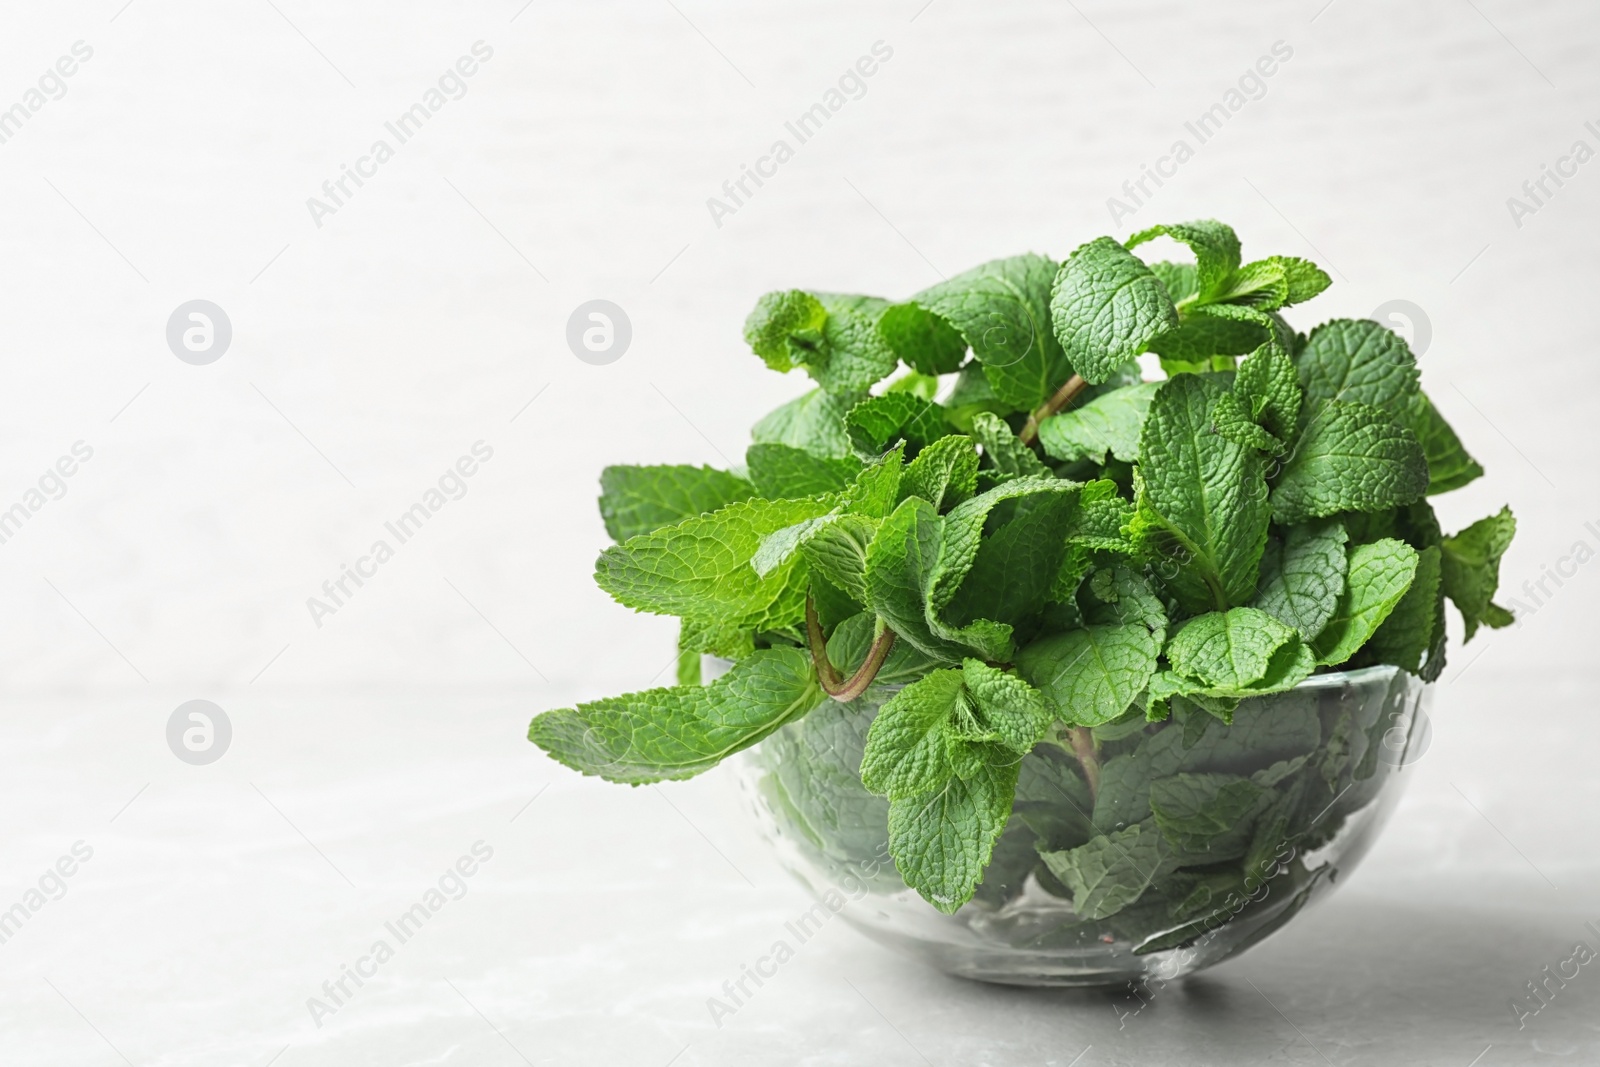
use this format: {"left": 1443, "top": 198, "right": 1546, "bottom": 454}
{"left": 1272, "top": 400, "right": 1427, "bottom": 525}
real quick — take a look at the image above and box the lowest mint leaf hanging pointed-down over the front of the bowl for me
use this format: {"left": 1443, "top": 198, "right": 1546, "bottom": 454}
{"left": 890, "top": 763, "right": 1016, "bottom": 915}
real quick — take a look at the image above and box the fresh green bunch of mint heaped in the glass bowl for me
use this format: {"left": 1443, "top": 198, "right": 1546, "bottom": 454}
{"left": 528, "top": 221, "right": 1515, "bottom": 913}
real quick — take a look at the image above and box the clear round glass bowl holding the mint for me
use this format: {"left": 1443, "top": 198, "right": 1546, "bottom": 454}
{"left": 739, "top": 667, "right": 1432, "bottom": 985}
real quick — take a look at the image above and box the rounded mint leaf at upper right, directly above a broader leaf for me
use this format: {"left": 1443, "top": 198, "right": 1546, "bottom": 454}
{"left": 1294, "top": 318, "right": 1418, "bottom": 418}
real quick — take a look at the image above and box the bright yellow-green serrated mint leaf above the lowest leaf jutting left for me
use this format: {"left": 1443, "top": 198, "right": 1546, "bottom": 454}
{"left": 595, "top": 499, "right": 830, "bottom": 629}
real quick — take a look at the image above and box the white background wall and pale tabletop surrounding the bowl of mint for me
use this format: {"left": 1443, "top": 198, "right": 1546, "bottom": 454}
{"left": 0, "top": 0, "right": 1600, "bottom": 1067}
